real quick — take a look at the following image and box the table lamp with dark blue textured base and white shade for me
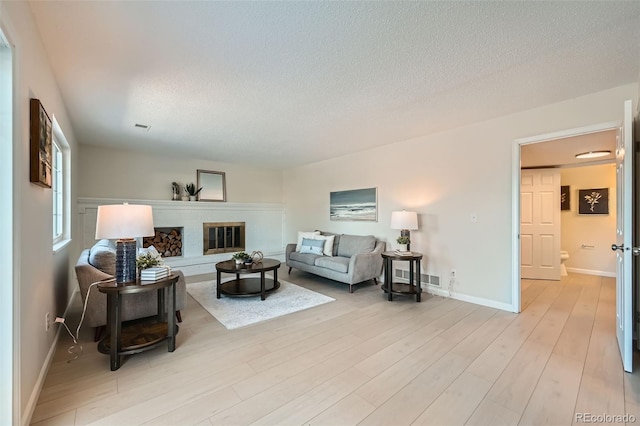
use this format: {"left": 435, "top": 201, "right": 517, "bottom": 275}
{"left": 96, "top": 203, "right": 154, "bottom": 283}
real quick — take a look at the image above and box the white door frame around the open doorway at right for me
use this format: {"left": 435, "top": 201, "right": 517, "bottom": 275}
{"left": 511, "top": 121, "right": 620, "bottom": 313}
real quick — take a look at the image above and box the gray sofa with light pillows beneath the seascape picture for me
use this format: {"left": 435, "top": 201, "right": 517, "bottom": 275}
{"left": 286, "top": 232, "right": 386, "bottom": 293}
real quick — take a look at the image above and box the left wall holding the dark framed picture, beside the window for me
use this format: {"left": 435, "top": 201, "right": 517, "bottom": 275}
{"left": 0, "top": 1, "right": 76, "bottom": 423}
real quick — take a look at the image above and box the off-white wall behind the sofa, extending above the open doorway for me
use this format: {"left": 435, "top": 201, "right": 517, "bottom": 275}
{"left": 283, "top": 84, "right": 638, "bottom": 308}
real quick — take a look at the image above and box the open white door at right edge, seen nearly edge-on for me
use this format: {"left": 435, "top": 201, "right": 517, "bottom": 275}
{"left": 611, "top": 101, "right": 634, "bottom": 372}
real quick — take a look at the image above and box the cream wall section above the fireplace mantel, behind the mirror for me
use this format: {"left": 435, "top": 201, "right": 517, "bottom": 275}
{"left": 78, "top": 145, "right": 282, "bottom": 203}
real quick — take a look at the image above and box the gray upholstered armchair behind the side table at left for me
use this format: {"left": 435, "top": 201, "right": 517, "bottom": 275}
{"left": 75, "top": 240, "right": 187, "bottom": 340}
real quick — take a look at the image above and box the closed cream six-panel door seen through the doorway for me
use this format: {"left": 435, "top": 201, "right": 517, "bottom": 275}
{"left": 520, "top": 169, "right": 560, "bottom": 280}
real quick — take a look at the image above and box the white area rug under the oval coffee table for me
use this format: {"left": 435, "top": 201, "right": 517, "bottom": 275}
{"left": 187, "top": 278, "right": 335, "bottom": 330}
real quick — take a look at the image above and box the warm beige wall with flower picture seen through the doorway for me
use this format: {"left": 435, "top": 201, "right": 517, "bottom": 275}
{"left": 561, "top": 164, "right": 616, "bottom": 276}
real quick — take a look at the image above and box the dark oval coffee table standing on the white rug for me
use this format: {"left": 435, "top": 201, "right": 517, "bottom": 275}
{"left": 216, "top": 259, "right": 280, "bottom": 300}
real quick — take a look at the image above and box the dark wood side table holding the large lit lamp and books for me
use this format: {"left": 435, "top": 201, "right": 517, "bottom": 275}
{"left": 98, "top": 275, "right": 178, "bottom": 371}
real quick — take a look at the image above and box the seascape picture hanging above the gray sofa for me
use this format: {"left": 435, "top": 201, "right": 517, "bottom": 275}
{"left": 329, "top": 188, "right": 378, "bottom": 222}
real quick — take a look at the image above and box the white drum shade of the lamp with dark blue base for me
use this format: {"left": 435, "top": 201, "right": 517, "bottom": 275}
{"left": 96, "top": 203, "right": 155, "bottom": 239}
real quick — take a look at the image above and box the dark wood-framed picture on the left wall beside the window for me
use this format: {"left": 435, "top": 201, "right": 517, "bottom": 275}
{"left": 29, "top": 99, "right": 53, "bottom": 188}
